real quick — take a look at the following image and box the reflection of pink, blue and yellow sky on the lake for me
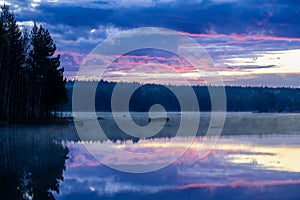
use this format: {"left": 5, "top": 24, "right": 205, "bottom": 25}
{"left": 57, "top": 135, "right": 300, "bottom": 200}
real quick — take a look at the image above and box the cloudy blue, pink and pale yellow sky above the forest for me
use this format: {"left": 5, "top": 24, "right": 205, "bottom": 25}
{"left": 0, "top": 0, "right": 300, "bottom": 87}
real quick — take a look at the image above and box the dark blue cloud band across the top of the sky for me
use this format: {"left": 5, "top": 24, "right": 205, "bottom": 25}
{"left": 12, "top": 0, "right": 300, "bottom": 37}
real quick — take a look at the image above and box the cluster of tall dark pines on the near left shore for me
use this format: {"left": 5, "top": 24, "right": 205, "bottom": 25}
{"left": 0, "top": 5, "right": 67, "bottom": 123}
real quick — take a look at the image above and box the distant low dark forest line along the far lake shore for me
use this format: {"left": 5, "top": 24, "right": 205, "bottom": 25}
{"left": 63, "top": 80, "right": 300, "bottom": 112}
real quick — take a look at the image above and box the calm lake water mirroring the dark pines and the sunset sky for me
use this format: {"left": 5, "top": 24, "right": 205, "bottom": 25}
{"left": 0, "top": 117, "right": 300, "bottom": 200}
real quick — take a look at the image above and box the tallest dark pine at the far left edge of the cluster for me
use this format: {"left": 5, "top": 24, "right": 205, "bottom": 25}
{"left": 1, "top": 5, "right": 25, "bottom": 122}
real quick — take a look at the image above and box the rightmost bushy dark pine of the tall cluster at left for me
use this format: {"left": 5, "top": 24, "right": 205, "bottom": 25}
{"left": 29, "top": 24, "right": 66, "bottom": 119}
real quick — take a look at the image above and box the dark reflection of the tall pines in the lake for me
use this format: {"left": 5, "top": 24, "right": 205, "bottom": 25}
{"left": 0, "top": 127, "right": 69, "bottom": 200}
